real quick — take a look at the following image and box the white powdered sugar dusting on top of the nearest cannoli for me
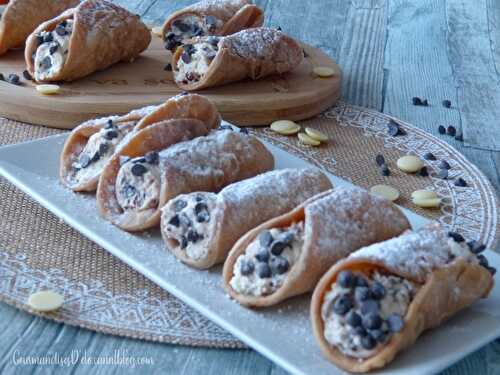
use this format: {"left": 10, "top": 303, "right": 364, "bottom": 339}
{"left": 350, "top": 224, "right": 477, "bottom": 282}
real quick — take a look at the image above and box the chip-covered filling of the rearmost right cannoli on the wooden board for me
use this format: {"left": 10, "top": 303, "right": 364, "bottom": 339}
{"left": 163, "top": 15, "right": 224, "bottom": 52}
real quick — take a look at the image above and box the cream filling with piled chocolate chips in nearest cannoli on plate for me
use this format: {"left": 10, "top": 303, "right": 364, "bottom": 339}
{"left": 321, "top": 271, "right": 418, "bottom": 360}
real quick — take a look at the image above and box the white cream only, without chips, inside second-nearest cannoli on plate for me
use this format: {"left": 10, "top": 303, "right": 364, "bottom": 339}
{"left": 230, "top": 222, "right": 304, "bottom": 296}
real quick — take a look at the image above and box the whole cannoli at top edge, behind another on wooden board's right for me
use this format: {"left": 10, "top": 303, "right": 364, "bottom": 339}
{"left": 162, "top": 0, "right": 264, "bottom": 52}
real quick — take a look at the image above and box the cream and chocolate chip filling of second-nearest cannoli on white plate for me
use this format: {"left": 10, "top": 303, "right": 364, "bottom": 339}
{"left": 230, "top": 222, "right": 304, "bottom": 296}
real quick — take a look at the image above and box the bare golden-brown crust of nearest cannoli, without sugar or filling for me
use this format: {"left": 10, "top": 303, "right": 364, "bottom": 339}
{"left": 311, "top": 225, "right": 493, "bottom": 372}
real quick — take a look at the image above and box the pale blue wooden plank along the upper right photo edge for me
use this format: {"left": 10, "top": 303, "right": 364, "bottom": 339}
{"left": 445, "top": 0, "right": 500, "bottom": 151}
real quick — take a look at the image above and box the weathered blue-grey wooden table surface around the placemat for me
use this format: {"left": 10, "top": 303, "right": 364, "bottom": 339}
{"left": 0, "top": 0, "right": 500, "bottom": 375}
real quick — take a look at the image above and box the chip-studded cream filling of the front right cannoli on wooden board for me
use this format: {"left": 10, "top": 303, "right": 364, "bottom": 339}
{"left": 174, "top": 37, "right": 219, "bottom": 84}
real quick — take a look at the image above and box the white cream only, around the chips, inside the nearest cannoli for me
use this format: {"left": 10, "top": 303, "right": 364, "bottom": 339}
{"left": 321, "top": 273, "right": 417, "bottom": 359}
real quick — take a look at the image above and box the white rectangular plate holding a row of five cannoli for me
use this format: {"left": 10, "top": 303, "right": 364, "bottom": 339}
{"left": 0, "top": 135, "right": 500, "bottom": 375}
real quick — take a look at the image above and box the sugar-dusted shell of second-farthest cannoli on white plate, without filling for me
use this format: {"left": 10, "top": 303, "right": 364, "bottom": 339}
{"left": 97, "top": 131, "right": 274, "bottom": 231}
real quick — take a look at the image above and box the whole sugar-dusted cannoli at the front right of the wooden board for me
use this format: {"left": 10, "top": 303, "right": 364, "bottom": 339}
{"left": 172, "top": 27, "right": 304, "bottom": 91}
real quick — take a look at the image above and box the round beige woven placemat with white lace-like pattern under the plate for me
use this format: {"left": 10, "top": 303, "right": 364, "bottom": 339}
{"left": 0, "top": 103, "right": 499, "bottom": 348}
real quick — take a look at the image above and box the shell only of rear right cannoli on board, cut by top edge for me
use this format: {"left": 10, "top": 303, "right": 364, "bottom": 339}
{"left": 162, "top": 0, "right": 264, "bottom": 39}
